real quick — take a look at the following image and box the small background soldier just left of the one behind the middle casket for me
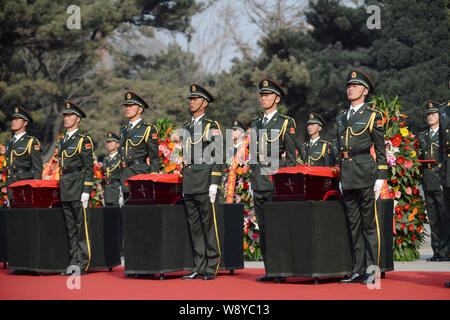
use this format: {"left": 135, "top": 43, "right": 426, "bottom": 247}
{"left": 103, "top": 132, "right": 123, "bottom": 206}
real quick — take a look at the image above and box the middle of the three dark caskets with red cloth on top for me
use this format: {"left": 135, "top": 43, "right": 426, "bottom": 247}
{"left": 127, "top": 174, "right": 183, "bottom": 205}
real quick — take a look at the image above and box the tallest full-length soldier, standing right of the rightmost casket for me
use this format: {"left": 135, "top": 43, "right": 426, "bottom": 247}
{"left": 336, "top": 70, "right": 388, "bottom": 284}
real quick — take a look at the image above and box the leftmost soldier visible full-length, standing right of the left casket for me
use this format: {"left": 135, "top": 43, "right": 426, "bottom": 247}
{"left": 57, "top": 102, "right": 94, "bottom": 275}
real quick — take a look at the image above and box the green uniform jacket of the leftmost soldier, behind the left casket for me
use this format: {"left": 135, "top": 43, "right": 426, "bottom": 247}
{"left": 5, "top": 133, "right": 42, "bottom": 198}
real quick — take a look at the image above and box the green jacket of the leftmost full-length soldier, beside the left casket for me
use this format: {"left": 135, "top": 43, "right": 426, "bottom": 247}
{"left": 57, "top": 130, "right": 94, "bottom": 201}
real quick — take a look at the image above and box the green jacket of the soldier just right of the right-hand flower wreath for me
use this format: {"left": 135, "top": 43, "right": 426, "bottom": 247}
{"left": 417, "top": 130, "right": 442, "bottom": 191}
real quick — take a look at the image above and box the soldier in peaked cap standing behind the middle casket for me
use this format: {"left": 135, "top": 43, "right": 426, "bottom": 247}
{"left": 119, "top": 91, "right": 160, "bottom": 200}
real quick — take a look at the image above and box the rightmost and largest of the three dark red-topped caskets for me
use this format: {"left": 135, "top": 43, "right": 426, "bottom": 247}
{"left": 272, "top": 165, "right": 340, "bottom": 202}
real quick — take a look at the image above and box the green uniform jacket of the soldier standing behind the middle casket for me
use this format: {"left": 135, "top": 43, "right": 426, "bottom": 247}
{"left": 119, "top": 120, "right": 160, "bottom": 192}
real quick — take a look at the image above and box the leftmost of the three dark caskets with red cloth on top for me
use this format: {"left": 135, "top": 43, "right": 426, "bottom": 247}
{"left": 9, "top": 180, "right": 60, "bottom": 208}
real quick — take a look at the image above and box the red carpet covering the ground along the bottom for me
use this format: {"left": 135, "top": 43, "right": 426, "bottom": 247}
{"left": 0, "top": 267, "right": 450, "bottom": 300}
